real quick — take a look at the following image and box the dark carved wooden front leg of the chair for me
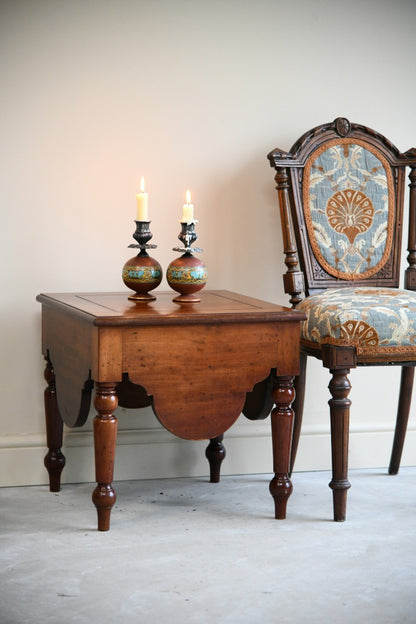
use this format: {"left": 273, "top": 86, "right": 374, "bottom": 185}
{"left": 328, "top": 368, "right": 351, "bottom": 522}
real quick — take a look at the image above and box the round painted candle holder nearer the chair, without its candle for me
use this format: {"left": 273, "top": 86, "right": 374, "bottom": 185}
{"left": 166, "top": 221, "right": 208, "bottom": 303}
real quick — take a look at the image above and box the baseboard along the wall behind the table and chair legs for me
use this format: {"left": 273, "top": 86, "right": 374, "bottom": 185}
{"left": 0, "top": 419, "right": 416, "bottom": 487}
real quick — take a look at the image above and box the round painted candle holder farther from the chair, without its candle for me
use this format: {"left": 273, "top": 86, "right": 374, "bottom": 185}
{"left": 122, "top": 221, "right": 163, "bottom": 301}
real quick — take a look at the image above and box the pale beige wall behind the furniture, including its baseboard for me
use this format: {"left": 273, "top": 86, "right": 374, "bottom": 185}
{"left": 0, "top": 0, "right": 416, "bottom": 485}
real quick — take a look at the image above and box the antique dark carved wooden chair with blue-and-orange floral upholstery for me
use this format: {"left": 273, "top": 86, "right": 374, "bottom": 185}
{"left": 268, "top": 117, "right": 416, "bottom": 521}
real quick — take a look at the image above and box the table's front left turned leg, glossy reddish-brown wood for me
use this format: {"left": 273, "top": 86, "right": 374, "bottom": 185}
{"left": 92, "top": 383, "right": 118, "bottom": 531}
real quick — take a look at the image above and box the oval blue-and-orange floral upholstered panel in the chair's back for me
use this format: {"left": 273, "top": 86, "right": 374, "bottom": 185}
{"left": 303, "top": 138, "right": 394, "bottom": 280}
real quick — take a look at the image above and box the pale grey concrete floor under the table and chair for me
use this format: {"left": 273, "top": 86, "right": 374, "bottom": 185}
{"left": 0, "top": 468, "right": 416, "bottom": 624}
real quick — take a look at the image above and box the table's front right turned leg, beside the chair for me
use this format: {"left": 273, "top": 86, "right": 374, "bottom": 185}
{"left": 269, "top": 377, "right": 295, "bottom": 520}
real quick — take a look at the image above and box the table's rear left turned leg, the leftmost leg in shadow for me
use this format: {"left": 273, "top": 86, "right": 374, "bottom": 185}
{"left": 44, "top": 357, "right": 65, "bottom": 492}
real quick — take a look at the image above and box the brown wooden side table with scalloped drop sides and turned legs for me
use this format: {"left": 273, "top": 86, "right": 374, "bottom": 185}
{"left": 37, "top": 291, "right": 304, "bottom": 531}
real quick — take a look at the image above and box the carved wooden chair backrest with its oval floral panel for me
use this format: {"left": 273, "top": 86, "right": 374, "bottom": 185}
{"left": 268, "top": 118, "right": 416, "bottom": 304}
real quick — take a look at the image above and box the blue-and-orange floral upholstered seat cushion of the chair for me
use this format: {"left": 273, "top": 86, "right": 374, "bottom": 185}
{"left": 297, "top": 286, "right": 416, "bottom": 361}
